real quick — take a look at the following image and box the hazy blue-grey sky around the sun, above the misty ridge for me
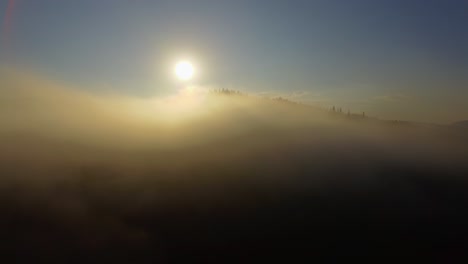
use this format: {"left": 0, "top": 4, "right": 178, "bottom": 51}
{"left": 0, "top": 0, "right": 468, "bottom": 123}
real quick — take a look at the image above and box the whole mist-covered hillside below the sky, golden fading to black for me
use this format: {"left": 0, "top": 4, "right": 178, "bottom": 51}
{"left": 0, "top": 72, "right": 468, "bottom": 263}
